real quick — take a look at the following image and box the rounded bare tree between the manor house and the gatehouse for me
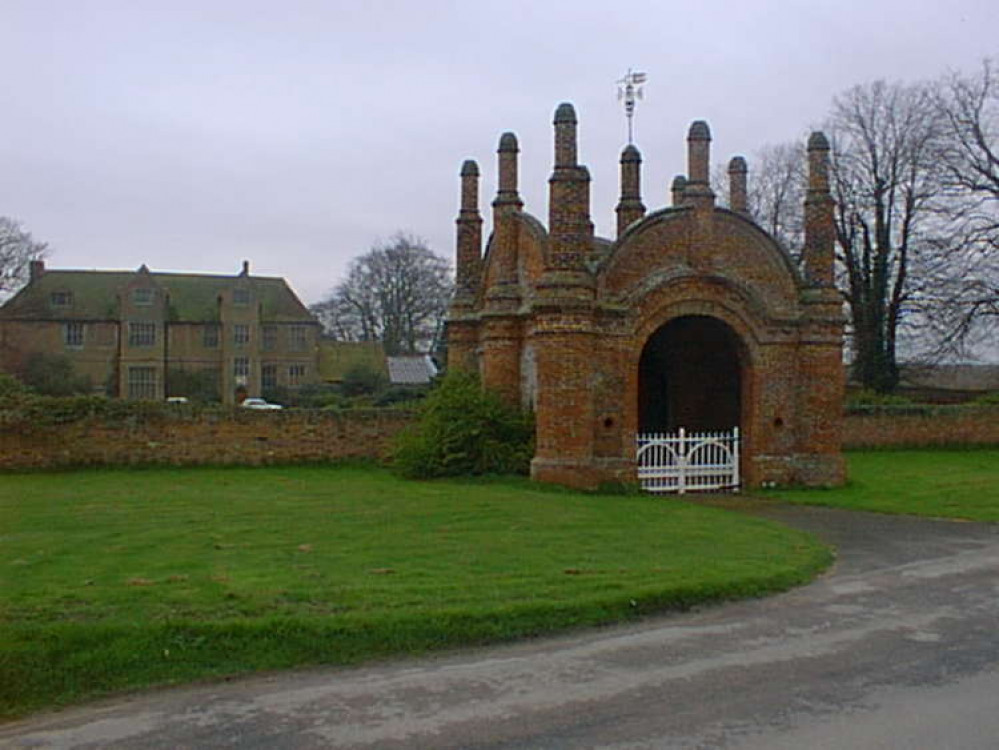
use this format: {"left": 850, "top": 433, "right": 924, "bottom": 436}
{"left": 312, "top": 234, "right": 453, "bottom": 354}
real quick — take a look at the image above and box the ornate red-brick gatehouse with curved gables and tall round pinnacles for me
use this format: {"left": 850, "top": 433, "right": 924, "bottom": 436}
{"left": 448, "top": 104, "right": 844, "bottom": 494}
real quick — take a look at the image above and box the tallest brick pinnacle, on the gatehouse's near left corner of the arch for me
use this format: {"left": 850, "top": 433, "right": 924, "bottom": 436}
{"left": 548, "top": 102, "right": 593, "bottom": 274}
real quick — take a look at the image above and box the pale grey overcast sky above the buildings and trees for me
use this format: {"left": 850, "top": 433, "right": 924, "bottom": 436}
{"left": 0, "top": 0, "right": 999, "bottom": 303}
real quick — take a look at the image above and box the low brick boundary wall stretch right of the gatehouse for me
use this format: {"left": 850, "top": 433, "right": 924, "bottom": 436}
{"left": 843, "top": 406, "right": 999, "bottom": 450}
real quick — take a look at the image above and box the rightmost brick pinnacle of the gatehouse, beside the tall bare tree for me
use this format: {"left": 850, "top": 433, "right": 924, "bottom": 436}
{"left": 804, "top": 131, "right": 835, "bottom": 287}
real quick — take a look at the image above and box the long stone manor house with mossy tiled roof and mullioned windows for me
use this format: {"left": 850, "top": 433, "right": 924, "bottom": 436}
{"left": 0, "top": 261, "right": 319, "bottom": 404}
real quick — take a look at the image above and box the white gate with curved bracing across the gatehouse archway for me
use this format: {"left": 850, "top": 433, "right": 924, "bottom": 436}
{"left": 638, "top": 427, "right": 739, "bottom": 495}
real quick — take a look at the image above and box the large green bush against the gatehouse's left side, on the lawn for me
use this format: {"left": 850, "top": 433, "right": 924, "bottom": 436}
{"left": 393, "top": 371, "right": 534, "bottom": 479}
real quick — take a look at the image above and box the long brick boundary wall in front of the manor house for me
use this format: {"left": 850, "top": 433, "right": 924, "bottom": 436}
{"left": 0, "top": 409, "right": 414, "bottom": 471}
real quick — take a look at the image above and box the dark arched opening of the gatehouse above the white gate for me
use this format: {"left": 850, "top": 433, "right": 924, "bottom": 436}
{"left": 638, "top": 315, "right": 742, "bottom": 433}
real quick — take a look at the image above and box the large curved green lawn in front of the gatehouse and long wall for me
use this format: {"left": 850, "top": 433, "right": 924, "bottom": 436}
{"left": 0, "top": 468, "right": 831, "bottom": 718}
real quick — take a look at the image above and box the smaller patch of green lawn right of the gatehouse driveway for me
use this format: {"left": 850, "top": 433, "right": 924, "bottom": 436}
{"left": 766, "top": 449, "right": 999, "bottom": 521}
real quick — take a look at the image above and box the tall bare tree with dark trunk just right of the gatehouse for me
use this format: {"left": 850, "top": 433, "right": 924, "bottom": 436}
{"left": 830, "top": 81, "right": 956, "bottom": 392}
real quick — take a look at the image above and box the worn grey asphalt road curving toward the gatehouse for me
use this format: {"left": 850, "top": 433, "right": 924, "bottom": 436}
{"left": 0, "top": 506, "right": 999, "bottom": 750}
